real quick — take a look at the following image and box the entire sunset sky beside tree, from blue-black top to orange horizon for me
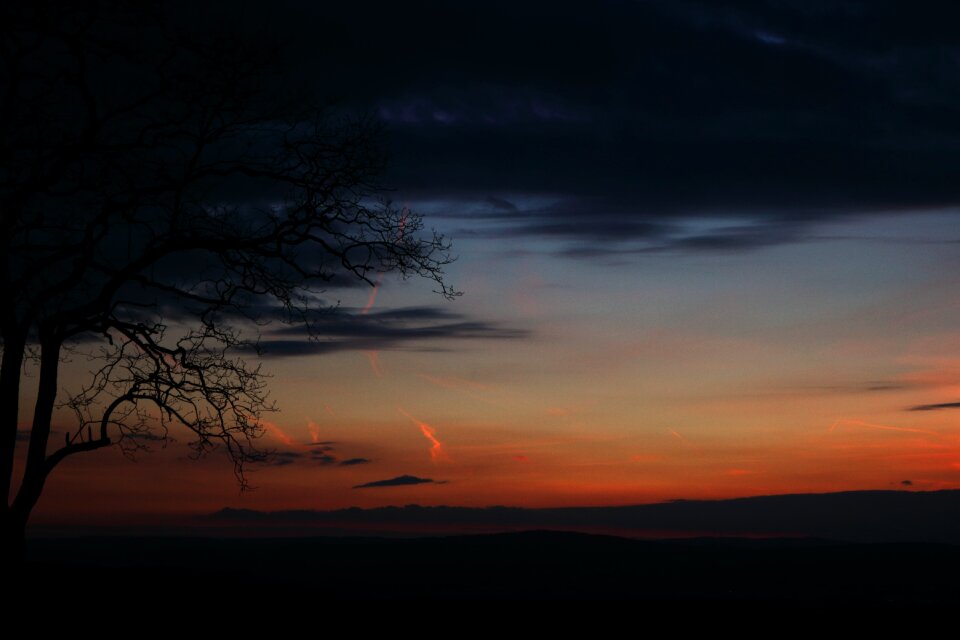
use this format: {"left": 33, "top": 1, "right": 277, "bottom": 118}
{"left": 26, "top": 0, "right": 960, "bottom": 522}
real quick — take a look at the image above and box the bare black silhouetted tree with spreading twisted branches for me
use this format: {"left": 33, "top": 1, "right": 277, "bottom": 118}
{"left": 0, "top": 2, "right": 454, "bottom": 558}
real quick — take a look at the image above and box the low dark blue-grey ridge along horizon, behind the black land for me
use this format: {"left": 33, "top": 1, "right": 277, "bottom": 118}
{"left": 205, "top": 490, "right": 960, "bottom": 544}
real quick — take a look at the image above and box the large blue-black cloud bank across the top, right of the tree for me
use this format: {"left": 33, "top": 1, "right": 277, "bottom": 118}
{"left": 251, "top": 0, "right": 960, "bottom": 257}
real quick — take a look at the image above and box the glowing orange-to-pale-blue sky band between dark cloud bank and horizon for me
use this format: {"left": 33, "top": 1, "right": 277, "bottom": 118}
{"left": 18, "top": 212, "right": 960, "bottom": 521}
